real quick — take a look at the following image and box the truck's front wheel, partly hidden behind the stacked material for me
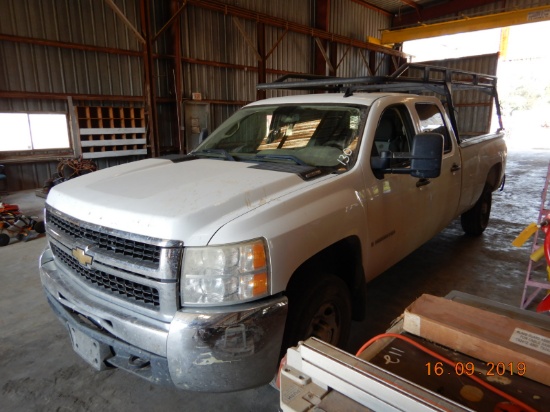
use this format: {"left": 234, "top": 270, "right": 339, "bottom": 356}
{"left": 282, "top": 273, "right": 351, "bottom": 352}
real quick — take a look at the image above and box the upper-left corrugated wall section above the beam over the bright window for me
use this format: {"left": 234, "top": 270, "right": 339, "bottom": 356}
{"left": 0, "top": 0, "right": 143, "bottom": 100}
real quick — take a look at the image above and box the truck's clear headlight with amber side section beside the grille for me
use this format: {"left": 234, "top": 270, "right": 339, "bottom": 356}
{"left": 181, "top": 240, "right": 268, "bottom": 305}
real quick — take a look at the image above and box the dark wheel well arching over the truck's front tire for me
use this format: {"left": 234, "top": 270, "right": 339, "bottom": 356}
{"left": 287, "top": 236, "right": 366, "bottom": 321}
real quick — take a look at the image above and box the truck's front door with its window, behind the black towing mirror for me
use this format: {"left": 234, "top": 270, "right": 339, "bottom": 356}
{"left": 365, "top": 104, "right": 433, "bottom": 275}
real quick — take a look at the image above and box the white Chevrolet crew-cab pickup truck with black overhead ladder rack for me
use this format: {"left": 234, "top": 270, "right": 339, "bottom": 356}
{"left": 40, "top": 62, "right": 506, "bottom": 391}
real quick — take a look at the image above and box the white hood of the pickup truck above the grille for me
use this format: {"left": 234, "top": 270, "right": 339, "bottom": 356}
{"left": 47, "top": 159, "right": 322, "bottom": 246}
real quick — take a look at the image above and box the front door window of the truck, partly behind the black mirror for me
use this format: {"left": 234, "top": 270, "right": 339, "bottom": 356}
{"left": 372, "top": 105, "right": 414, "bottom": 167}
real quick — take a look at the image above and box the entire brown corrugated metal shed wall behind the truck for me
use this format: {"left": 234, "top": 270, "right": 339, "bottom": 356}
{"left": 0, "top": 0, "right": 406, "bottom": 190}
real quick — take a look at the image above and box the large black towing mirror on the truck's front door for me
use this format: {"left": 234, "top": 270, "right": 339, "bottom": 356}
{"left": 411, "top": 133, "right": 443, "bottom": 179}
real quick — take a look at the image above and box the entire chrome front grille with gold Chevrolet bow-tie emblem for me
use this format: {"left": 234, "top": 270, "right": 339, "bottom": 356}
{"left": 45, "top": 205, "right": 183, "bottom": 321}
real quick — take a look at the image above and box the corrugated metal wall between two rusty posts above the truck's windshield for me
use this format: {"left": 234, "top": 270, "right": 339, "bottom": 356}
{"left": 182, "top": 0, "right": 312, "bottom": 112}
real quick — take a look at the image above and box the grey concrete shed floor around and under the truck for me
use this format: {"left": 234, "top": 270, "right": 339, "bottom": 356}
{"left": 0, "top": 143, "right": 550, "bottom": 411}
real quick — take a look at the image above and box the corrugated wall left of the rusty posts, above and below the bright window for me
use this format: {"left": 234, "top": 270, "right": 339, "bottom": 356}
{"left": 0, "top": 0, "right": 144, "bottom": 191}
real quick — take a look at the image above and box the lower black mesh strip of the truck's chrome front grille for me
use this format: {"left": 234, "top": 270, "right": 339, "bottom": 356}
{"left": 52, "top": 244, "right": 160, "bottom": 307}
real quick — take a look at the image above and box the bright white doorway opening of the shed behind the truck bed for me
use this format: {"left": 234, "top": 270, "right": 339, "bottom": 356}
{"left": 403, "top": 21, "right": 550, "bottom": 150}
